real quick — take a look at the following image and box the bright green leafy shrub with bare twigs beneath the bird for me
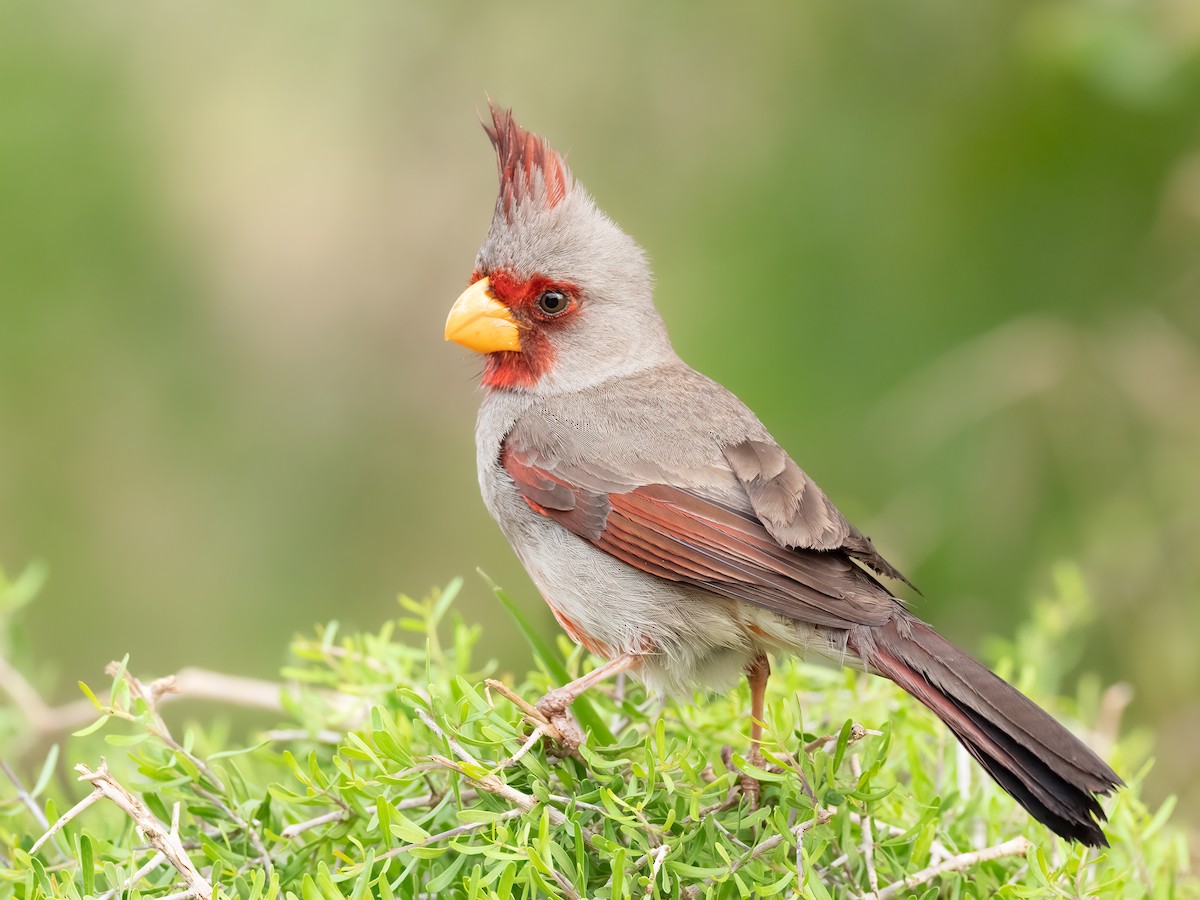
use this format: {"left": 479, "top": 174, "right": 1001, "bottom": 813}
{"left": 0, "top": 570, "right": 1200, "bottom": 900}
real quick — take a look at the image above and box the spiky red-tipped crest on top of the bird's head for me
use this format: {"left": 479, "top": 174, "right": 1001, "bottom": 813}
{"left": 482, "top": 100, "right": 571, "bottom": 216}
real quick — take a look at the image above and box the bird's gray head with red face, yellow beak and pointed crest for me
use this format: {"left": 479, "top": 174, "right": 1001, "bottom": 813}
{"left": 446, "top": 106, "right": 674, "bottom": 394}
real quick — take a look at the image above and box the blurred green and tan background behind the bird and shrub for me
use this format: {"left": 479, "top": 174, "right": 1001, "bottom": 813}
{"left": 0, "top": 0, "right": 1200, "bottom": 818}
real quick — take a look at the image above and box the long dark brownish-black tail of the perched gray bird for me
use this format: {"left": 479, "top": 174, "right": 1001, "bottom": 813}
{"left": 858, "top": 616, "right": 1122, "bottom": 847}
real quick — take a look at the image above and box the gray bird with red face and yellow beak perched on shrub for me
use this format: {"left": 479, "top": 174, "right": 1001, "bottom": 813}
{"left": 445, "top": 101, "right": 1122, "bottom": 846}
